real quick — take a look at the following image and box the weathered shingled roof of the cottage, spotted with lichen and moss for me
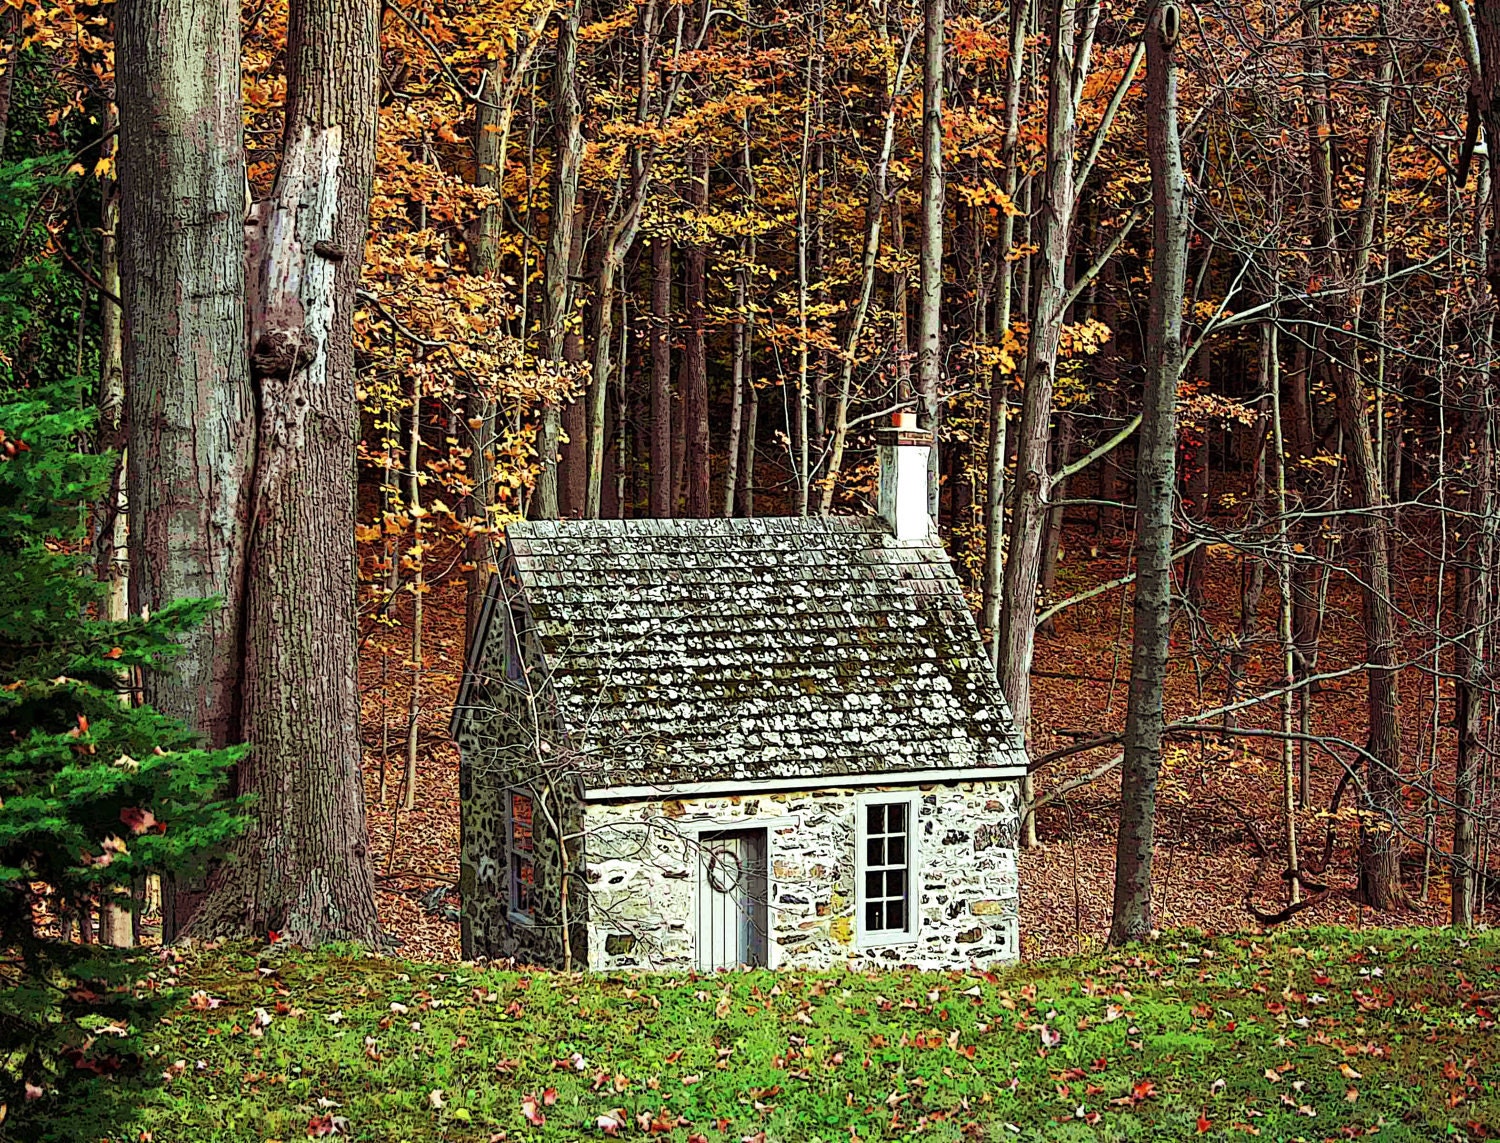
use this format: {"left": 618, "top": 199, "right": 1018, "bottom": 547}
{"left": 455, "top": 516, "right": 1025, "bottom": 791}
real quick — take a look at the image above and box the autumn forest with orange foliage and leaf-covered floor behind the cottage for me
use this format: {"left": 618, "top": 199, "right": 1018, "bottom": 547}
{"left": 0, "top": 0, "right": 1500, "bottom": 972}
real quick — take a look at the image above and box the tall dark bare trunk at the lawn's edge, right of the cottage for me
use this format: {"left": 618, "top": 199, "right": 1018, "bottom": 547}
{"left": 1110, "top": 0, "right": 1188, "bottom": 945}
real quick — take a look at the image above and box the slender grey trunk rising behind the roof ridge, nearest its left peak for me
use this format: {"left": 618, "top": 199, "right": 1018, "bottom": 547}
{"left": 531, "top": 5, "right": 584, "bottom": 521}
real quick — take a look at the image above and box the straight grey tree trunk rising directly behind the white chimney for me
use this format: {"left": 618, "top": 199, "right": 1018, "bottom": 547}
{"left": 917, "top": 0, "right": 948, "bottom": 513}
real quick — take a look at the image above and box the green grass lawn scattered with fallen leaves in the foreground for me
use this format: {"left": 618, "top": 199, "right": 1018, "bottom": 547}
{"left": 14, "top": 930, "right": 1500, "bottom": 1143}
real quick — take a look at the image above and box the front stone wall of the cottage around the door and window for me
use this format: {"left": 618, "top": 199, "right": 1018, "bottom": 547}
{"left": 584, "top": 782, "right": 1020, "bottom": 969}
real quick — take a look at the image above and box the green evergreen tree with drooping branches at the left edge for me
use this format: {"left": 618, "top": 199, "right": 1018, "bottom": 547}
{"left": 0, "top": 162, "right": 240, "bottom": 1109}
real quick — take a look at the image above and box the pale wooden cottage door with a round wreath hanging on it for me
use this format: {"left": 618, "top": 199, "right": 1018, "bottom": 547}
{"left": 695, "top": 830, "right": 768, "bottom": 972}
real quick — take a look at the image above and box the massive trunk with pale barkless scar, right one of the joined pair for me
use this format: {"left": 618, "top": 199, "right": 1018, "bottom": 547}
{"left": 192, "top": 0, "right": 384, "bottom": 945}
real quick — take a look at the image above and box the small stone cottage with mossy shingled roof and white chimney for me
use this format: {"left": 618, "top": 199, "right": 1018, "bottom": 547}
{"left": 452, "top": 417, "right": 1026, "bottom": 971}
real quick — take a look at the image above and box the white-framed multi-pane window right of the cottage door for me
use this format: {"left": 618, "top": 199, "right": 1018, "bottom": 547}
{"left": 855, "top": 794, "right": 918, "bottom": 945}
